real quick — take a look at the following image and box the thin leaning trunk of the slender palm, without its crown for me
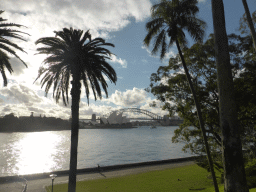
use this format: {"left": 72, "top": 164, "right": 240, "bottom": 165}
{"left": 176, "top": 40, "right": 219, "bottom": 192}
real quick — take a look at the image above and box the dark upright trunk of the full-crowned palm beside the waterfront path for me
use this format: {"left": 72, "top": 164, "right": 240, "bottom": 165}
{"left": 68, "top": 76, "right": 81, "bottom": 192}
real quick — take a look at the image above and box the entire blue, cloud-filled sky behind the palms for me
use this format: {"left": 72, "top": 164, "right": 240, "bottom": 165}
{"left": 0, "top": 0, "right": 256, "bottom": 119}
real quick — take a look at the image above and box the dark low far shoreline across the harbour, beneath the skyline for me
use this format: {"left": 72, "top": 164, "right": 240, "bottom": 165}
{"left": 0, "top": 113, "right": 183, "bottom": 133}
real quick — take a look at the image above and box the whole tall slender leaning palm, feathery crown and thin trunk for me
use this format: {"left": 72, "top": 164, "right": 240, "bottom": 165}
{"left": 144, "top": 0, "right": 219, "bottom": 192}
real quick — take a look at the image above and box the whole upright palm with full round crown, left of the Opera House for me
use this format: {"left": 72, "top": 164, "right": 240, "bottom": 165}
{"left": 35, "top": 28, "right": 117, "bottom": 192}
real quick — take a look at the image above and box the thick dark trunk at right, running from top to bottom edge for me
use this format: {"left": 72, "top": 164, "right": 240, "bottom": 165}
{"left": 212, "top": 0, "right": 249, "bottom": 192}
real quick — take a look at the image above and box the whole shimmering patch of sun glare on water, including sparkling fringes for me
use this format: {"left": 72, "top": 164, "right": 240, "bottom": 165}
{"left": 2, "top": 131, "right": 69, "bottom": 175}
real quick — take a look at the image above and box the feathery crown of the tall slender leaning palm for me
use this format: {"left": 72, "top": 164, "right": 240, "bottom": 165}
{"left": 144, "top": 0, "right": 206, "bottom": 59}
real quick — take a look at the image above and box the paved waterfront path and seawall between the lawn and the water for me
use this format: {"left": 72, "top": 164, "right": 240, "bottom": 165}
{"left": 0, "top": 157, "right": 195, "bottom": 192}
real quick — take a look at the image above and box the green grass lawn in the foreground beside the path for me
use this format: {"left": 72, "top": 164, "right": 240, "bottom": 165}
{"left": 46, "top": 165, "right": 256, "bottom": 192}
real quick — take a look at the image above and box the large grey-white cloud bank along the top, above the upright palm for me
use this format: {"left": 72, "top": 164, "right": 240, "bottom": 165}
{"left": 1, "top": 0, "right": 152, "bottom": 42}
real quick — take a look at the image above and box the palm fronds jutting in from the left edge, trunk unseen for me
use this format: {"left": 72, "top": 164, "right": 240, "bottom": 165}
{"left": 0, "top": 10, "right": 29, "bottom": 86}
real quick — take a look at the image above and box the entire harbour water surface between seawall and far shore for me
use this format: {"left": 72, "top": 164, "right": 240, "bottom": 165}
{"left": 0, "top": 126, "right": 192, "bottom": 177}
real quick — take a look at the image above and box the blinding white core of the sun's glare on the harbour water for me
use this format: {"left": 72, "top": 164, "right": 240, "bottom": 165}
{"left": 13, "top": 132, "right": 61, "bottom": 175}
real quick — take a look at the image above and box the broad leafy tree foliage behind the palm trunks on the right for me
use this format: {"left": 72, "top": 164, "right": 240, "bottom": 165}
{"left": 147, "top": 34, "right": 256, "bottom": 158}
